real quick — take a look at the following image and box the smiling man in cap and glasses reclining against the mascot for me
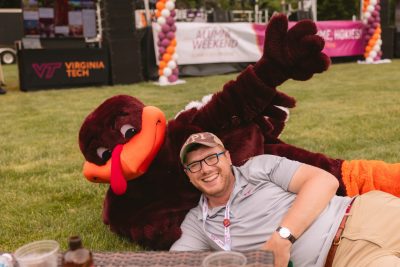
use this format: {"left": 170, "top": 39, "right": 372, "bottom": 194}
{"left": 170, "top": 132, "right": 400, "bottom": 267}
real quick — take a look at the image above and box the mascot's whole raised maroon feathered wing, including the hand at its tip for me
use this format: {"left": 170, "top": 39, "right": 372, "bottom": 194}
{"left": 177, "top": 15, "right": 330, "bottom": 137}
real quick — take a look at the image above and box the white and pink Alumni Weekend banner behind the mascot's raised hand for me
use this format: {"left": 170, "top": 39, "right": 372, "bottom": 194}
{"left": 153, "top": 21, "right": 364, "bottom": 65}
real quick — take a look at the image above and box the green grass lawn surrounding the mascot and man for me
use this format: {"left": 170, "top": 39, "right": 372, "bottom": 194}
{"left": 0, "top": 60, "right": 400, "bottom": 251}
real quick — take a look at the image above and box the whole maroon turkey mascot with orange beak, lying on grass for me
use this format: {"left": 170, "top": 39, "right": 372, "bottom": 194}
{"left": 79, "top": 15, "right": 400, "bottom": 250}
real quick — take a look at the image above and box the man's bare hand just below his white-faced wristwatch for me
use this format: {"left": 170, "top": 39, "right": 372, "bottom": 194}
{"left": 261, "top": 232, "right": 292, "bottom": 267}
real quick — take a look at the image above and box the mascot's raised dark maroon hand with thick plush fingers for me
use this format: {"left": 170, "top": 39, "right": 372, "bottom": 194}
{"left": 255, "top": 14, "right": 330, "bottom": 86}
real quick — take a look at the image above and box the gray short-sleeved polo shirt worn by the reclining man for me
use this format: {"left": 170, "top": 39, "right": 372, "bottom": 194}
{"left": 170, "top": 155, "right": 351, "bottom": 267}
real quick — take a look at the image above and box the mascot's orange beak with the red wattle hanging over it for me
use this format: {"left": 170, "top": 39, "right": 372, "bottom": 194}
{"left": 83, "top": 106, "right": 166, "bottom": 195}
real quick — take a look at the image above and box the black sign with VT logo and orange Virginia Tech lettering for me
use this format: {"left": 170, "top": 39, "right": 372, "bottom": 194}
{"left": 18, "top": 48, "right": 109, "bottom": 91}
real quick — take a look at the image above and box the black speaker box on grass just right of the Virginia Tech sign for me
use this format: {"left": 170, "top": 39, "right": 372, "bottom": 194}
{"left": 108, "top": 36, "right": 143, "bottom": 84}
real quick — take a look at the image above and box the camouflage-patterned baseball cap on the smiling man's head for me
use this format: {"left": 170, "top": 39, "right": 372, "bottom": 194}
{"left": 179, "top": 132, "right": 225, "bottom": 163}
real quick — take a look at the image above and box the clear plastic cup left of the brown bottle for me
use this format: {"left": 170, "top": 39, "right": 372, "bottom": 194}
{"left": 14, "top": 240, "right": 60, "bottom": 267}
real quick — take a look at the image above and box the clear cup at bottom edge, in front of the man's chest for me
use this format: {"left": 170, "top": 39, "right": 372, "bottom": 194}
{"left": 203, "top": 251, "right": 247, "bottom": 267}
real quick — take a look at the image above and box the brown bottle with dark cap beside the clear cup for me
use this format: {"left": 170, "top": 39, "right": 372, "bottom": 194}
{"left": 62, "top": 236, "right": 94, "bottom": 267}
